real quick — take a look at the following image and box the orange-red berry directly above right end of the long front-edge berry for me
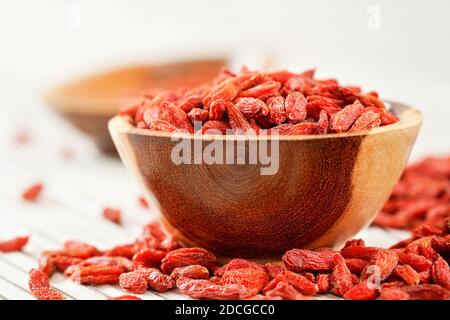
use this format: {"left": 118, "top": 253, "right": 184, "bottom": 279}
{"left": 220, "top": 268, "right": 269, "bottom": 292}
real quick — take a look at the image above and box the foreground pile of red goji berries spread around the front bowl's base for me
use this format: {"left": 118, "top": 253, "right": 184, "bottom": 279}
{"left": 29, "top": 216, "right": 450, "bottom": 300}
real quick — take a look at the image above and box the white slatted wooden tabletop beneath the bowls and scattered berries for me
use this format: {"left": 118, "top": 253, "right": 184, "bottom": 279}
{"left": 0, "top": 98, "right": 407, "bottom": 299}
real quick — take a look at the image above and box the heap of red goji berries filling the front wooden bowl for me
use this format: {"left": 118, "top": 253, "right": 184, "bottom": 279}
{"left": 119, "top": 67, "right": 398, "bottom": 135}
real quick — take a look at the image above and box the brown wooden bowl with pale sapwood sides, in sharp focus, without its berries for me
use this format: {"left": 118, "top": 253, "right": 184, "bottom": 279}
{"left": 109, "top": 103, "right": 421, "bottom": 259}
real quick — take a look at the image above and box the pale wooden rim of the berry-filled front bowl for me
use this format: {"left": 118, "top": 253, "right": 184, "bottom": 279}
{"left": 108, "top": 101, "right": 422, "bottom": 141}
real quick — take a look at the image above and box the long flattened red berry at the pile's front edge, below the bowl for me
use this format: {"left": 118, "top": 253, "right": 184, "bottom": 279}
{"left": 177, "top": 277, "right": 256, "bottom": 300}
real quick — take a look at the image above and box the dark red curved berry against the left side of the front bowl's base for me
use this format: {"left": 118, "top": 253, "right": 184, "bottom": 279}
{"left": 161, "top": 248, "right": 216, "bottom": 274}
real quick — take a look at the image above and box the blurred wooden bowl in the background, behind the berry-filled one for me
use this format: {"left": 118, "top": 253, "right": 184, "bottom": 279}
{"left": 46, "top": 59, "right": 226, "bottom": 153}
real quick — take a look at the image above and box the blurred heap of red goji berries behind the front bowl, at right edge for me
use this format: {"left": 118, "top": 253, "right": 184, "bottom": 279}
{"left": 374, "top": 156, "right": 450, "bottom": 229}
